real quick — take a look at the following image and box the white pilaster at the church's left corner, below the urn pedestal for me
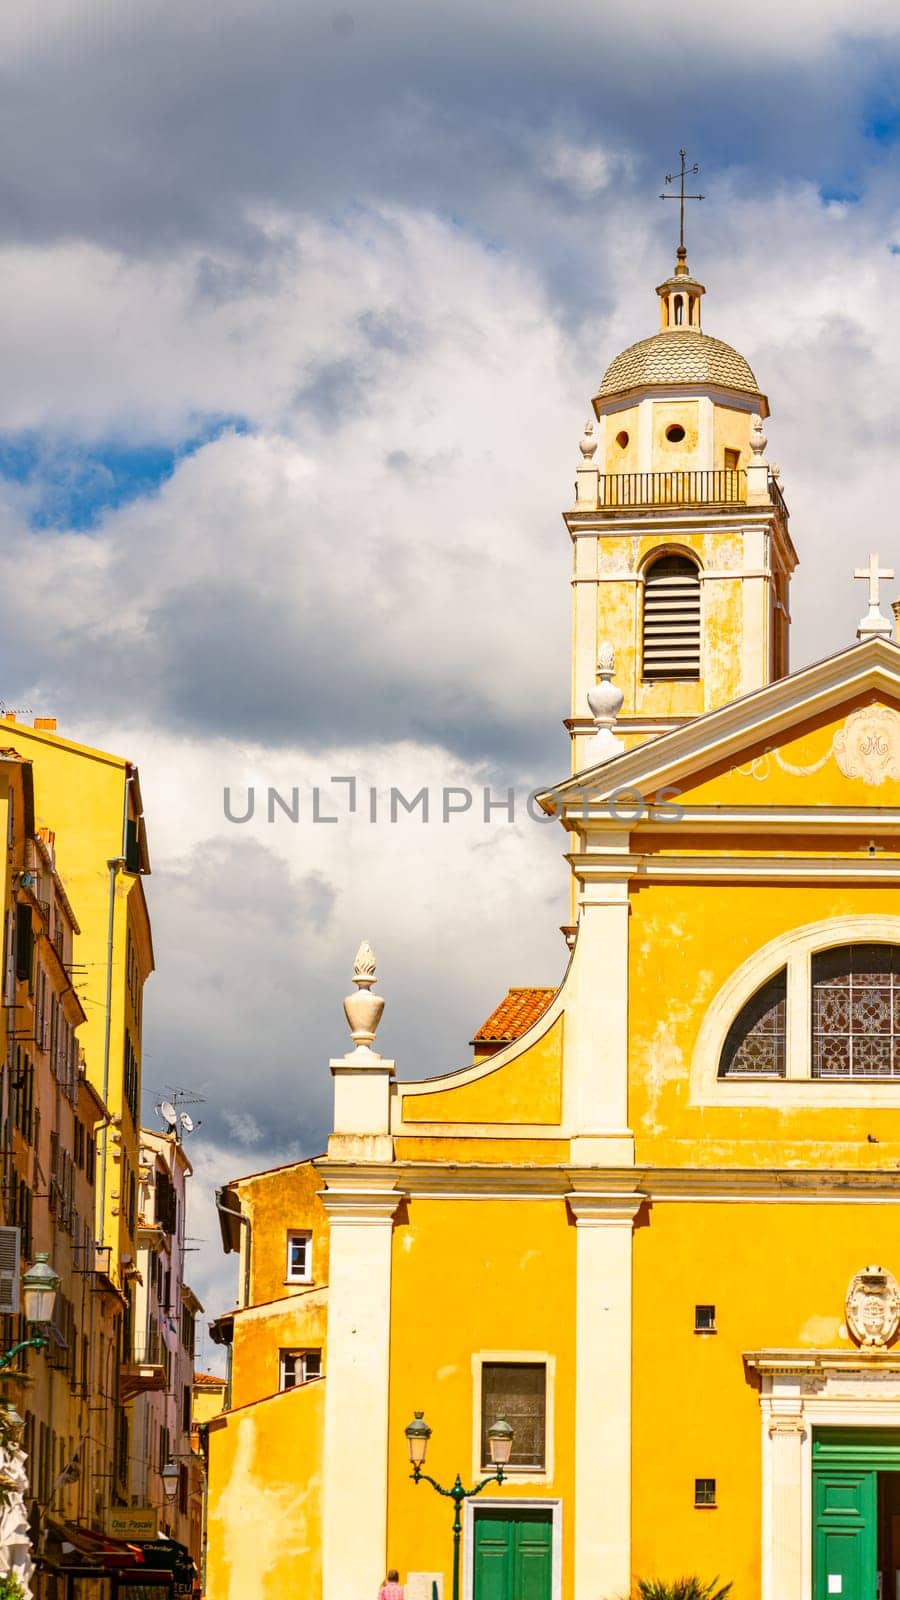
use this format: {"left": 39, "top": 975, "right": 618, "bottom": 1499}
{"left": 322, "top": 1173, "right": 400, "bottom": 1600}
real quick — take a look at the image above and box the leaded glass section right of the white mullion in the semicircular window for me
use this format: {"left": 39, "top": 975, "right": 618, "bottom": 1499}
{"left": 812, "top": 944, "right": 900, "bottom": 1078}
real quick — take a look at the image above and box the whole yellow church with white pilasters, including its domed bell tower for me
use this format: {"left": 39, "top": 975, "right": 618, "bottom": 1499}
{"left": 208, "top": 251, "right": 900, "bottom": 1600}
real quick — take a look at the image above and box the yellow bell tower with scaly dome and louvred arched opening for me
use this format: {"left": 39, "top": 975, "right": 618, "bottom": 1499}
{"left": 565, "top": 243, "right": 798, "bottom": 771}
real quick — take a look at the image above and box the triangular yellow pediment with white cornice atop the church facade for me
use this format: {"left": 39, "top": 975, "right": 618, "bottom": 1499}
{"left": 541, "top": 638, "right": 900, "bottom": 814}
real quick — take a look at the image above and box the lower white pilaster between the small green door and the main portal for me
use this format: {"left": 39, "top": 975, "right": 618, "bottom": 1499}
{"left": 569, "top": 1194, "right": 641, "bottom": 1600}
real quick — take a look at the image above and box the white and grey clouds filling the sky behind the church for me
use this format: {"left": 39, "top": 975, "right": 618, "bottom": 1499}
{"left": 0, "top": 0, "right": 900, "bottom": 1324}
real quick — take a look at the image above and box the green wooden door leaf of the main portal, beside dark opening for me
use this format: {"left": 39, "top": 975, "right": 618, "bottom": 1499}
{"left": 812, "top": 1467, "right": 878, "bottom": 1600}
